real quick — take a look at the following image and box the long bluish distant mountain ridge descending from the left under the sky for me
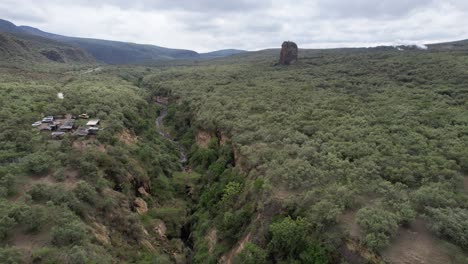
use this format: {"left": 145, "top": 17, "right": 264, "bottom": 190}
{"left": 0, "top": 19, "right": 249, "bottom": 64}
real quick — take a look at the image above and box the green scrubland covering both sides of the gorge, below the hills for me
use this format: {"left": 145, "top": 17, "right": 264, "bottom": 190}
{"left": 0, "top": 44, "right": 468, "bottom": 263}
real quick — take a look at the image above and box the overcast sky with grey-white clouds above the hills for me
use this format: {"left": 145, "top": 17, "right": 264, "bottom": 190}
{"left": 0, "top": 0, "right": 468, "bottom": 52}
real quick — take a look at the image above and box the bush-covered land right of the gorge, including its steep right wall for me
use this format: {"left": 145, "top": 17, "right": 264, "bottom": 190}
{"left": 143, "top": 44, "right": 468, "bottom": 264}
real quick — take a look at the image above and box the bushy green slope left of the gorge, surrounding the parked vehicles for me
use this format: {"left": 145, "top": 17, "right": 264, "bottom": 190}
{"left": 0, "top": 64, "right": 194, "bottom": 263}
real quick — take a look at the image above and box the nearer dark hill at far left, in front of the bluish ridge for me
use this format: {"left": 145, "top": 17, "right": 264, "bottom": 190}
{"left": 0, "top": 31, "right": 96, "bottom": 66}
